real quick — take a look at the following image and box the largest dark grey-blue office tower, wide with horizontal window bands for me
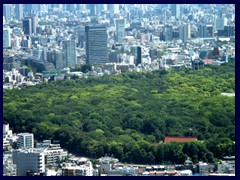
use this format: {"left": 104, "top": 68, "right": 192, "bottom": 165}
{"left": 85, "top": 26, "right": 109, "bottom": 64}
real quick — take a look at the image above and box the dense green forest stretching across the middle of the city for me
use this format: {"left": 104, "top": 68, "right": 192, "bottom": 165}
{"left": 3, "top": 63, "right": 235, "bottom": 164}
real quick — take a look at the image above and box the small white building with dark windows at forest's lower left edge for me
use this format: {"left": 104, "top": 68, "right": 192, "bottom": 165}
{"left": 17, "top": 133, "right": 34, "bottom": 149}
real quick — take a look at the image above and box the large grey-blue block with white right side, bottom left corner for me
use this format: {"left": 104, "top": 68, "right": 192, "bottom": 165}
{"left": 13, "top": 149, "right": 45, "bottom": 176}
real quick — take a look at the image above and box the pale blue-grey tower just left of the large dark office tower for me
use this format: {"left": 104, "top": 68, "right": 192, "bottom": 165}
{"left": 62, "top": 40, "right": 77, "bottom": 67}
